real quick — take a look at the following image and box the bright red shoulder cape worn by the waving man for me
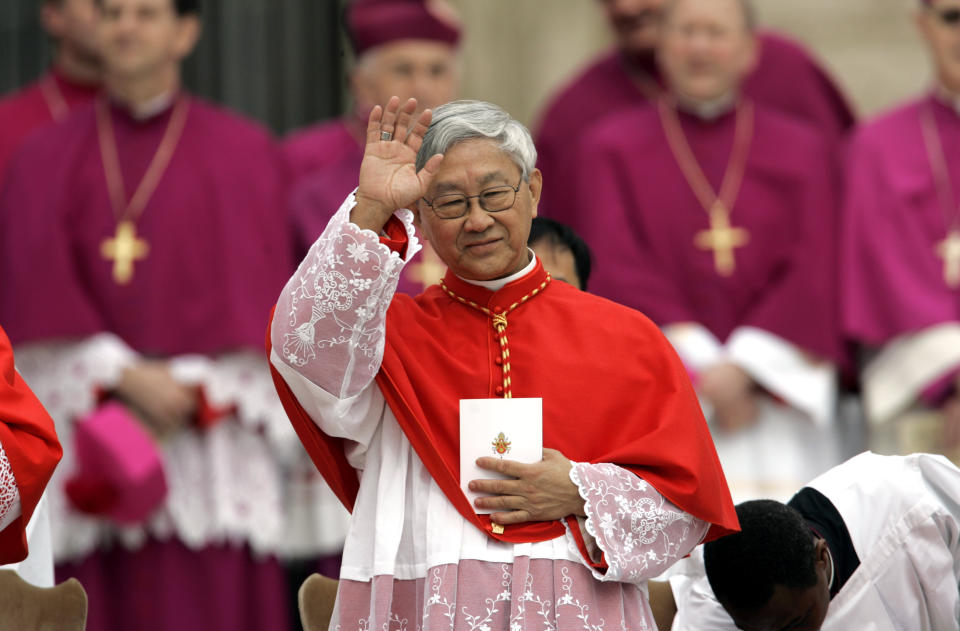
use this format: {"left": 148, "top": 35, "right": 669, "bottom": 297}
{"left": 268, "top": 242, "right": 738, "bottom": 543}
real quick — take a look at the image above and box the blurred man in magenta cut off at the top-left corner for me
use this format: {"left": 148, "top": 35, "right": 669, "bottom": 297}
{"left": 0, "top": 0, "right": 101, "bottom": 183}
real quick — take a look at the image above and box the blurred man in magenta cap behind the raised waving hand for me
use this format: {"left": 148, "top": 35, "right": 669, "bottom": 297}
{"left": 285, "top": 0, "right": 460, "bottom": 295}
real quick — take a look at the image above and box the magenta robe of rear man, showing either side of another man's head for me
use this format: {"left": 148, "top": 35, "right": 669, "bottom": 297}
{"left": 536, "top": 33, "right": 854, "bottom": 231}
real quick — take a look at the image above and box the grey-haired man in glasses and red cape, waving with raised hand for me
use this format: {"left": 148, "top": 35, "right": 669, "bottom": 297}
{"left": 270, "top": 98, "right": 737, "bottom": 630}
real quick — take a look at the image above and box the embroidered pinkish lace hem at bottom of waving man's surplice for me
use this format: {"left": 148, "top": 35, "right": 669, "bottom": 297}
{"left": 330, "top": 556, "right": 655, "bottom": 631}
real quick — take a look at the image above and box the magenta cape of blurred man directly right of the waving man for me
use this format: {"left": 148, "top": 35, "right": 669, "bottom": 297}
{"left": 577, "top": 105, "right": 838, "bottom": 358}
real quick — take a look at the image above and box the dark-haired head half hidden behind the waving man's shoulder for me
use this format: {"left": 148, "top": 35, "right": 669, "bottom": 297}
{"left": 527, "top": 217, "right": 593, "bottom": 291}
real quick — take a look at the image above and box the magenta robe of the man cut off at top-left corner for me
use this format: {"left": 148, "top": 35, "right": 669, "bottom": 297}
{"left": 0, "top": 68, "right": 99, "bottom": 188}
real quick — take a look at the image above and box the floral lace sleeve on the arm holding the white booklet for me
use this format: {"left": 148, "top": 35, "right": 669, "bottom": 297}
{"left": 570, "top": 463, "right": 710, "bottom": 583}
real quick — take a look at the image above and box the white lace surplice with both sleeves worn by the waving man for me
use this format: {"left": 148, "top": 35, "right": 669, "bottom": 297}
{"left": 271, "top": 196, "right": 709, "bottom": 631}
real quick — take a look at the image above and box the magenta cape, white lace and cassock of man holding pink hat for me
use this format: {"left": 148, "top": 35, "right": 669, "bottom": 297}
{"left": 0, "top": 94, "right": 292, "bottom": 631}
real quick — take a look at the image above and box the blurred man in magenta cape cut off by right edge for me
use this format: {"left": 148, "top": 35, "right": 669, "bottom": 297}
{"left": 841, "top": 0, "right": 960, "bottom": 462}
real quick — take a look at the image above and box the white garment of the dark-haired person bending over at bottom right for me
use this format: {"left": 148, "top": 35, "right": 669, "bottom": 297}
{"left": 670, "top": 452, "right": 960, "bottom": 631}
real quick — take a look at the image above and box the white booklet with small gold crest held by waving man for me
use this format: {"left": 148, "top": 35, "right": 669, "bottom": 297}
{"left": 460, "top": 399, "right": 543, "bottom": 513}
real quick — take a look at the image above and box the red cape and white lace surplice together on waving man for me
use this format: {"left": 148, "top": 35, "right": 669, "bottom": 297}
{"left": 270, "top": 195, "right": 735, "bottom": 631}
